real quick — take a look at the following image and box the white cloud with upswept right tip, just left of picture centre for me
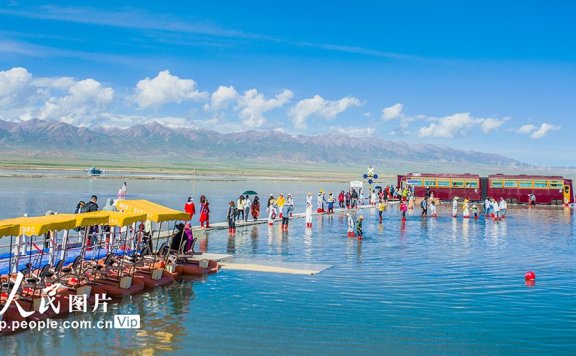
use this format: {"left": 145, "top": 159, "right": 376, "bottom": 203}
{"left": 236, "top": 89, "right": 294, "bottom": 128}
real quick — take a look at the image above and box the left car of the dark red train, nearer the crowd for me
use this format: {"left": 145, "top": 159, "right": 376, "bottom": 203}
{"left": 398, "top": 173, "right": 482, "bottom": 200}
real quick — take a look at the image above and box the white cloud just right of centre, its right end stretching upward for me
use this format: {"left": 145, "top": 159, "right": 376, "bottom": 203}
{"left": 288, "top": 95, "right": 360, "bottom": 129}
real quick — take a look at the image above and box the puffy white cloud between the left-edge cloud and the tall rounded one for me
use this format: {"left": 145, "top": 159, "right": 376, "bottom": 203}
{"left": 38, "top": 79, "right": 114, "bottom": 125}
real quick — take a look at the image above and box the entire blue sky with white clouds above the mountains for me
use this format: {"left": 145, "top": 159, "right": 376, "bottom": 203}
{"left": 0, "top": 0, "right": 576, "bottom": 166}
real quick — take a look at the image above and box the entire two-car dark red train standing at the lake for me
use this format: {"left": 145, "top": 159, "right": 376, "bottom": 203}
{"left": 398, "top": 173, "right": 574, "bottom": 205}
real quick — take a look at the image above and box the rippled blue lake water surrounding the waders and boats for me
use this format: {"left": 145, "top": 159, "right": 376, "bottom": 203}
{"left": 0, "top": 178, "right": 576, "bottom": 355}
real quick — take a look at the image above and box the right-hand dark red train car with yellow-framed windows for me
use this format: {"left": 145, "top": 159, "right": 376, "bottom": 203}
{"left": 485, "top": 174, "right": 574, "bottom": 205}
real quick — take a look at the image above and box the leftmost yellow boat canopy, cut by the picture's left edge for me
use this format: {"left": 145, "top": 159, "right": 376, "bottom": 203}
{"left": 2, "top": 214, "right": 76, "bottom": 236}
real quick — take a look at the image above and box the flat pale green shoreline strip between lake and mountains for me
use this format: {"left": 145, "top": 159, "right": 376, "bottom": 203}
{"left": 0, "top": 157, "right": 576, "bottom": 182}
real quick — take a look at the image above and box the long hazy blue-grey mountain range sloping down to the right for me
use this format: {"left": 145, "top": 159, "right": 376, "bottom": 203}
{"left": 0, "top": 119, "right": 522, "bottom": 166}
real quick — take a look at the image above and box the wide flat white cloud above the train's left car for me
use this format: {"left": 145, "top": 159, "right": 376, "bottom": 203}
{"left": 418, "top": 113, "right": 505, "bottom": 138}
